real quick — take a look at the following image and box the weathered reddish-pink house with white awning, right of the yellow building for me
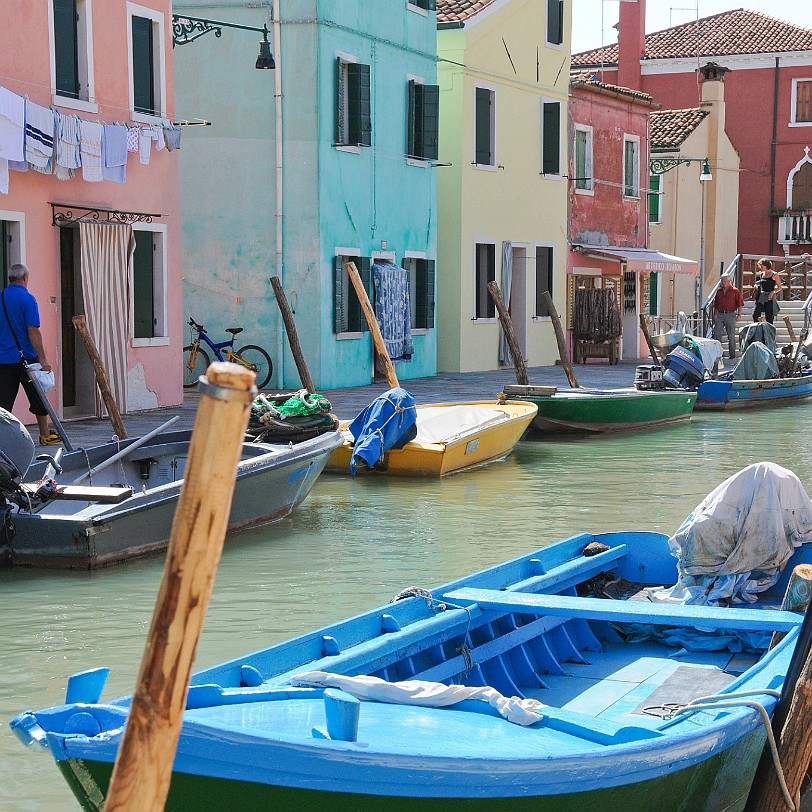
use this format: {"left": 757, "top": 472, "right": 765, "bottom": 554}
{"left": 567, "top": 74, "right": 697, "bottom": 358}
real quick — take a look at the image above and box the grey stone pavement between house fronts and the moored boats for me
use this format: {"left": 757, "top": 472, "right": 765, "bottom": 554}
{"left": 38, "top": 359, "right": 651, "bottom": 451}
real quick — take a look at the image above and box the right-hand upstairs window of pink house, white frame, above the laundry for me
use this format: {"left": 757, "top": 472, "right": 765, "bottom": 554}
{"left": 127, "top": 3, "right": 166, "bottom": 121}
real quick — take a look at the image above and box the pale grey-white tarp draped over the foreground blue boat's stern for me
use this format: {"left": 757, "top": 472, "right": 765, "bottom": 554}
{"left": 655, "top": 462, "right": 812, "bottom": 605}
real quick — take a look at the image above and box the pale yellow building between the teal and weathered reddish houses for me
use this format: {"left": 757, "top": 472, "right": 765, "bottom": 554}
{"left": 437, "top": 0, "right": 572, "bottom": 372}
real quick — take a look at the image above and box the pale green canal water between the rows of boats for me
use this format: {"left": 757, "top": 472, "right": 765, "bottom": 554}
{"left": 0, "top": 403, "right": 812, "bottom": 812}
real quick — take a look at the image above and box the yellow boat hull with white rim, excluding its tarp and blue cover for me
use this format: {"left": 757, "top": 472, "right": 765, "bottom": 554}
{"left": 325, "top": 400, "right": 538, "bottom": 477}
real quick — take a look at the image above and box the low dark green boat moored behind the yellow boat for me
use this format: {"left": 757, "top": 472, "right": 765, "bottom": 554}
{"left": 504, "top": 385, "right": 696, "bottom": 434}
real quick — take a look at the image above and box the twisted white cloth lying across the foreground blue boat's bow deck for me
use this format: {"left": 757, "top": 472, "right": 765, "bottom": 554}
{"left": 290, "top": 671, "right": 546, "bottom": 726}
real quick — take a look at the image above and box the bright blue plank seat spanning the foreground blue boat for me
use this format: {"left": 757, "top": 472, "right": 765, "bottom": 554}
{"left": 443, "top": 588, "right": 802, "bottom": 632}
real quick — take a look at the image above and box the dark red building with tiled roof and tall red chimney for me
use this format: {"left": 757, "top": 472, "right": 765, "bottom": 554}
{"left": 572, "top": 7, "right": 812, "bottom": 266}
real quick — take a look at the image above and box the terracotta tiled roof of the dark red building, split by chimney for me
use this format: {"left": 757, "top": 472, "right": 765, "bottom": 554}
{"left": 572, "top": 8, "right": 812, "bottom": 67}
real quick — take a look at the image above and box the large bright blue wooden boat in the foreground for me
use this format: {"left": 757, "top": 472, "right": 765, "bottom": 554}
{"left": 11, "top": 532, "right": 812, "bottom": 812}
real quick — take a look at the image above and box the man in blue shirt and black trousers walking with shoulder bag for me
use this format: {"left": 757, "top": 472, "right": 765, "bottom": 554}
{"left": 0, "top": 263, "right": 61, "bottom": 445}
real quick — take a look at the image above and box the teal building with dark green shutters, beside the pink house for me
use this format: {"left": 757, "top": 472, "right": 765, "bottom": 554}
{"left": 174, "top": 0, "right": 443, "bottom": 389}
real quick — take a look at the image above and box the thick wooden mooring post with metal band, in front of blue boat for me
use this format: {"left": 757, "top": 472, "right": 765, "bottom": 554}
{"left": 104, "top": 362, "right": 256, "bottom": 812}
